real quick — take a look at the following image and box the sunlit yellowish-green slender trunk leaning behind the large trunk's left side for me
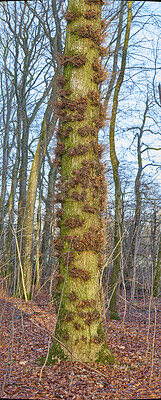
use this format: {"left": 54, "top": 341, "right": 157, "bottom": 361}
{"left": 21, "top": 77, "right": 57, "bottom": 298}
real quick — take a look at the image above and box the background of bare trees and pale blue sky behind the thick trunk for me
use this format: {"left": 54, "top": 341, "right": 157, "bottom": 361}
{"left": 0, "top": 0, "right": 161, "bottom": 398}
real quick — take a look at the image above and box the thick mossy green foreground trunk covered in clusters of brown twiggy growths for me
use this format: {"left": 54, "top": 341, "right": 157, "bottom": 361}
{"left": 48, "top": 0, "right": 114, "bottom": 363}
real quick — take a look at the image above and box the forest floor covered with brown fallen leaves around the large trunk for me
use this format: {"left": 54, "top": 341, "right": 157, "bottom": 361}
{"left": 0, "top": 282, "right": 161, "bottom": 400}
